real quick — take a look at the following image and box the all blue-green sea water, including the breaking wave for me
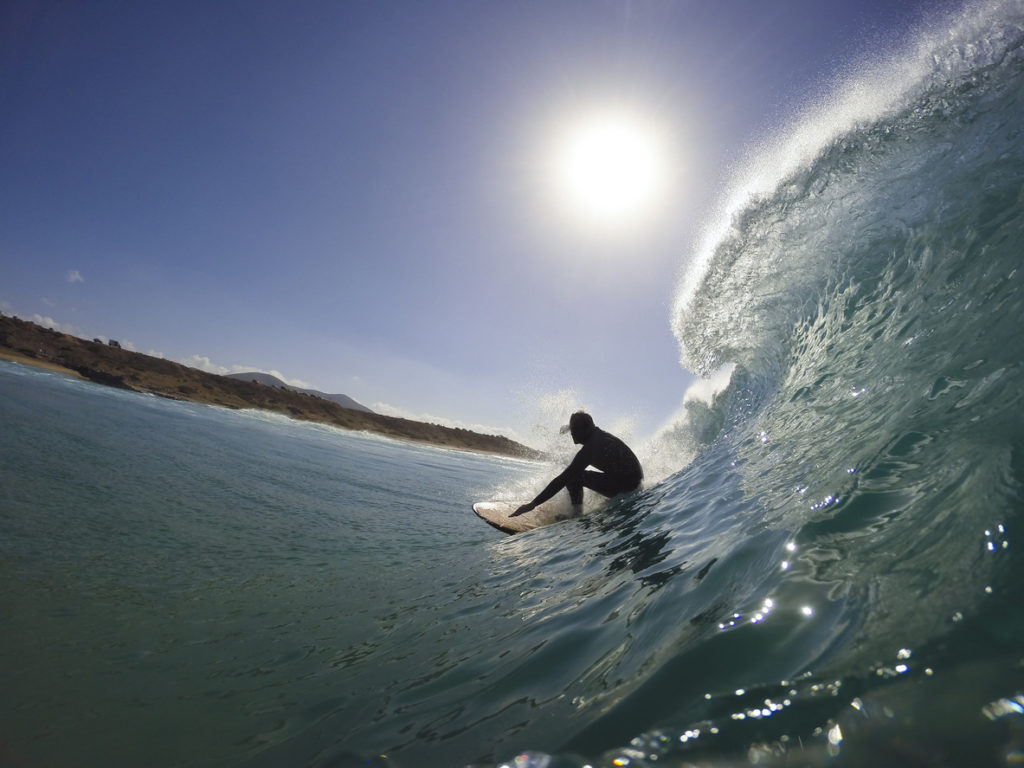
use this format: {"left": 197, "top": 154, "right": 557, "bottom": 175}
{"left": 6, "top": 2, "right": 1024, "bottom": 768}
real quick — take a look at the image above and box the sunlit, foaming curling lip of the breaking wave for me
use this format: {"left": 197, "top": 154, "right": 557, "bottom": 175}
{"left": 673, "top": 2, "right": 1024, "bottom": 385}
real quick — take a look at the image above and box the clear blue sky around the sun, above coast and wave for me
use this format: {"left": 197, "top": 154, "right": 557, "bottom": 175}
{"left": 0, "top": 0, "right": 935, "bottom": 442}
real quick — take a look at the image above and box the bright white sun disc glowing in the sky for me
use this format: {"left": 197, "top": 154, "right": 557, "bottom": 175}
{"left": 553, "top": 110, "right": 670, "bottom": 229}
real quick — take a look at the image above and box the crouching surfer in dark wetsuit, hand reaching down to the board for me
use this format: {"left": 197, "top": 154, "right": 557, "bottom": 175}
{"left": 509, "top": 411, "right": 643, "bottom": 517}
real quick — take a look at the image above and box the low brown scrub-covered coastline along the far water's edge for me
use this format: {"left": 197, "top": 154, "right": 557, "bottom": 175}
{"left": 0, "top": 314, "right": 543, "bottom": 459}
